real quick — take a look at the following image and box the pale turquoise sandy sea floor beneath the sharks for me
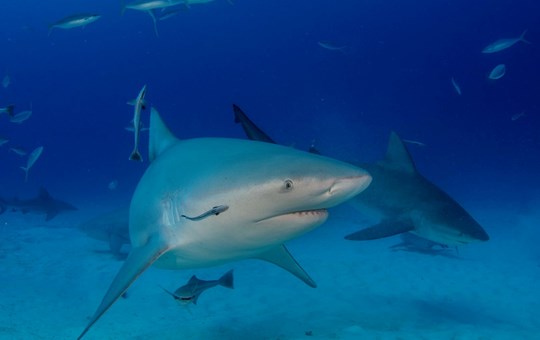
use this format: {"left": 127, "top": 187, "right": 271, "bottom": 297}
{"left": 0, "top": 203, "right": 540, "bottom": 339}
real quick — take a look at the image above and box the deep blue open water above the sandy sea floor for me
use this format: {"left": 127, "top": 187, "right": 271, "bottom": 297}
{"left": 0, "top": 0, "right": 540, "bottom": 338}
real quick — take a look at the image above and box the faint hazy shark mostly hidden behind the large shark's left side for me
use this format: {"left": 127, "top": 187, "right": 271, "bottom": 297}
{"left": 78, "top": 206, "right": 131, "bottom": 258}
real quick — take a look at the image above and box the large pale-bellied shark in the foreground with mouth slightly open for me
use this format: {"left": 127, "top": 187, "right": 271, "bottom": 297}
{"left": 79, "top": 109, "right": 371, "bottom": 339}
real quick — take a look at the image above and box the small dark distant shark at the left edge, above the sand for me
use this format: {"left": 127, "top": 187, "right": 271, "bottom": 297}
{"left": 0, "top": 187, "right": 77, "bottom": 221}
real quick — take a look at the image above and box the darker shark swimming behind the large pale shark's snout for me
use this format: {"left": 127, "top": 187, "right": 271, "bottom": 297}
{"left": 232, "top": 105, "right": 489, "bottom": 245}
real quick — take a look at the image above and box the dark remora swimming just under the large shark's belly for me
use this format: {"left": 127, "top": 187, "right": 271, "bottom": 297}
{"left": 161, "top": 269, "right": 234, "bottom": 305}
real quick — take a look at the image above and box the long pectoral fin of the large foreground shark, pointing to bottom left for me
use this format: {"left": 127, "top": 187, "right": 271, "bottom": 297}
{"left": 77, "top": 235, "right": 169, "bottom": 339}
